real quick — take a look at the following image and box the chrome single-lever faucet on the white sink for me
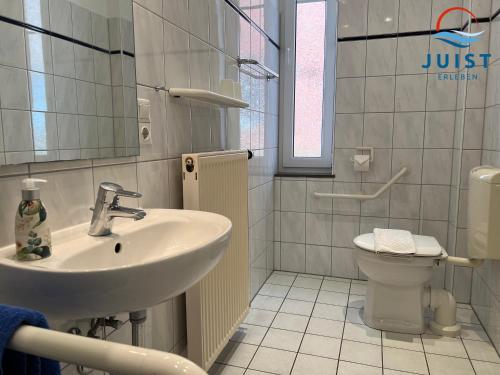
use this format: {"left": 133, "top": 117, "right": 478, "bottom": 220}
{"left": 89, "top": 182, "right": 146, "bottom": 236}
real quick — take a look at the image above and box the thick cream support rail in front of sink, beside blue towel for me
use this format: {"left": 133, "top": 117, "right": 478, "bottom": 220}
{"left": 7, "top": 326, "right": 207, "bottom": 375}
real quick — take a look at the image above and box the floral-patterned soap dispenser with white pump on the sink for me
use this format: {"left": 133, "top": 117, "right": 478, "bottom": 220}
{"left": 15, "top": 178, "right": 52, "bottom": 261}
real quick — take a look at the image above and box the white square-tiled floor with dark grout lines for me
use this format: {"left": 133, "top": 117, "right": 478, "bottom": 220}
{"left": 209, "top": 272, "right": 500, "bottom": 375}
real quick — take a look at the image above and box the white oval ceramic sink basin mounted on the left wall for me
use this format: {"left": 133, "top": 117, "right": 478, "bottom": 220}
{"left": 0, "top": 209, "right": 232, "bottom": 319}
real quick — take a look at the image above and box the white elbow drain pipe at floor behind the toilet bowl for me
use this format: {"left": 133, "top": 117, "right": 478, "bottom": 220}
{"left": 423, "top": 287, "right": 461, "bottom": 337}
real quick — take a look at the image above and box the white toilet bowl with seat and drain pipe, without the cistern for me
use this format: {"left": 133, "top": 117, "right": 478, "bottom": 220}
{"left": 354, "top": 233, "right": 460, "bottom": 336}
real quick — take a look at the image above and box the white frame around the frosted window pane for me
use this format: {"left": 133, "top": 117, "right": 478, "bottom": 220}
{"left": 280, "top": 0, "right": 338, "bottom": 173}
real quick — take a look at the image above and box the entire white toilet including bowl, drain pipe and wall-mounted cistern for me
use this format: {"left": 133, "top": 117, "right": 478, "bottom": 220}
{"left": 354, "top": 166, "right": 500, "bottom": 337}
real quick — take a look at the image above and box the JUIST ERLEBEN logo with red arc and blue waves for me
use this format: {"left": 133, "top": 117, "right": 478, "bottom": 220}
{"left": 422, "top": 7, "right": 491, "bottom": 80}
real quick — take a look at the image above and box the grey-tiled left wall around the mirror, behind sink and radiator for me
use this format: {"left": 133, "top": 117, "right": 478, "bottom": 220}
{"left": 0, "top": 0, "right": 279, "bottom": 374}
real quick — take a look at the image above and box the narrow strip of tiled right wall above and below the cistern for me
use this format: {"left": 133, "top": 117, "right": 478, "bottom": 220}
{"left": 472, "top": 0, "right": 500, "bottom": 356}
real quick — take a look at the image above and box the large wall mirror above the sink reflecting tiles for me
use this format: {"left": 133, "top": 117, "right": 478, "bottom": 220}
{"left": 0, "top": 0, "right": 139, "bottom": 165}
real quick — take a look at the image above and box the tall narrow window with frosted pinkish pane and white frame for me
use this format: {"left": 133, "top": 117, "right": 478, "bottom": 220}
{"left": 281, "top": 0, "right": 337, "bottom": 169}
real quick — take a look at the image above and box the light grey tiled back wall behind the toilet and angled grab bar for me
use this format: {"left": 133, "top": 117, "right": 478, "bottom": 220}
{"left": 275, "top": 0, "right": 491, "bottom": 302}
